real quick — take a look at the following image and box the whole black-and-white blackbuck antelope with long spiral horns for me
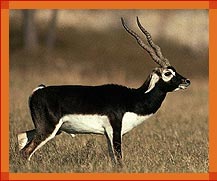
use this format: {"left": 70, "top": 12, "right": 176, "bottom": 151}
{"left": 18, "top": 17, "right": 190, "bottom": 163}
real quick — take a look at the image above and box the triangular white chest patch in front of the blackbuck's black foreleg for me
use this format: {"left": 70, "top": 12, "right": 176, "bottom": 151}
{"left": 121, "top": 112, "right": 152, "bottom": 135}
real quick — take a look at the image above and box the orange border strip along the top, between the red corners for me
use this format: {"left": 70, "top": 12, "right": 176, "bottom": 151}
{"left": 9, "top": 1, "right": 209, "bottom": 9}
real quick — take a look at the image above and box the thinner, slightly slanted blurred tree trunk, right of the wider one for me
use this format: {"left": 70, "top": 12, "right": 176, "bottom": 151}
{"left": 46, "top": 9, "right": 58, "bottom": 51}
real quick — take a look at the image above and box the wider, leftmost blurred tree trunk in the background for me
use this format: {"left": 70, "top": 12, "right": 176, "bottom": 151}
{"left": 23, "top": 10, "right": 39, "bottom": 52}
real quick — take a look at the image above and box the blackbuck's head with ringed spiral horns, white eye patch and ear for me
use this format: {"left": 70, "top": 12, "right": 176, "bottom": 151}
{"left": 121, "top": 17, "right": 190, "bottom": 93}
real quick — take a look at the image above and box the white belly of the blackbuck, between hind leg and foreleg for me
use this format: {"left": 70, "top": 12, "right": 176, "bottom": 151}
{"left": 60, "top": 114, "right": 110, "bottom": 134}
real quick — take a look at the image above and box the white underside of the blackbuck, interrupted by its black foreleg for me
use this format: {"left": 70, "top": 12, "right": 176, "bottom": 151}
{"left": 60, "top": 112, "right": 152, "bottom": 135}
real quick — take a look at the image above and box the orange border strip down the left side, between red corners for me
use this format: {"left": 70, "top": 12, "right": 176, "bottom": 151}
{"left": 1, "top": 6, "right": 9, "bottom": 175}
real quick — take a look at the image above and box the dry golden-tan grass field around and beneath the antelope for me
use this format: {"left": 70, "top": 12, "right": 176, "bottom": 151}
{"left": 10, "top": 60, "right": 208, "bottom": 172}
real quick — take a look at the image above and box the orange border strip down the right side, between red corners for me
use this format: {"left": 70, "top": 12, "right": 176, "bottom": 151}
{"left": 209, "top": 6, "right": 217, "bottom": 178}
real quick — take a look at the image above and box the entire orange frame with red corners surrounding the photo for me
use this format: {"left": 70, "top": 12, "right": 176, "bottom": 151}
{"left": 1, "top": 1, "right": 217, "bottom": 180}
